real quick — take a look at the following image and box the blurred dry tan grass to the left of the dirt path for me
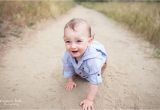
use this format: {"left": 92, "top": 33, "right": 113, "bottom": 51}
{"left": 0, "top": 1, "right": 75, "bottom": 38}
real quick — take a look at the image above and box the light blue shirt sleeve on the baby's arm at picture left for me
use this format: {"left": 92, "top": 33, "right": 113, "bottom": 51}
{"left": 63, "top": 52, "right": 75, "bottom": 78}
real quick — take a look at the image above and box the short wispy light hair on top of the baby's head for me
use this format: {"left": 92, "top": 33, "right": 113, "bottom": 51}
{"left": 64, "top": 18, "right": 91, "bottom": 37}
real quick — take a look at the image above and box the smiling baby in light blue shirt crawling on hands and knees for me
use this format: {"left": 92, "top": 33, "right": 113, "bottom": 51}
{"left": 63, "top": 18, "right": 107, "bottom": 110}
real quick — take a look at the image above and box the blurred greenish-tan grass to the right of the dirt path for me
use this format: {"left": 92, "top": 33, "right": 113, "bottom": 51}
{"left": 81, "top": 2, "right": 160, "bottom": 56}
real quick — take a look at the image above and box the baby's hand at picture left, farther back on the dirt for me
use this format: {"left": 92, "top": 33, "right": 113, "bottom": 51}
{"left": 65, "top": 77, "right": 76, "bottom": 90}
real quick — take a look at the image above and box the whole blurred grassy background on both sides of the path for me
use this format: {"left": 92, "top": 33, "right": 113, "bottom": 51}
{"left": 0, "top": 0, "right": 160, "bottom": 57}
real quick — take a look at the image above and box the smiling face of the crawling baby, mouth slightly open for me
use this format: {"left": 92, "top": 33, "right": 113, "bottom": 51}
{"left": 64, "top": 27, "right": 92, "bottom": 60}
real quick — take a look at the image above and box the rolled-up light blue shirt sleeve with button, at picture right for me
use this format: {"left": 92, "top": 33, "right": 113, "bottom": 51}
{"left": 87, "top": 58, "right": 102, "bottom": 85}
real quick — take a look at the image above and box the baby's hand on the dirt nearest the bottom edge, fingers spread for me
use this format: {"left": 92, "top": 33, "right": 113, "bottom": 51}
{"left": 80, "top": 99, "right": 94, "bottom": 110}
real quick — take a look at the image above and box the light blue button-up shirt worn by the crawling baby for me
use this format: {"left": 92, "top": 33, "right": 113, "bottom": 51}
{"left": 63, "top": 41, "right": 107, "bottom": 84}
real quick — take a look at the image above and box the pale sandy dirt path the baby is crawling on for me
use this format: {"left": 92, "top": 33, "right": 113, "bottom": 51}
{"left": 0, "top": 6, "right": 160, "bottom": 110}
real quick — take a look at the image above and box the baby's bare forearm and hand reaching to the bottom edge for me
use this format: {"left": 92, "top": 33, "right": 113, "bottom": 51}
{"left": 80, "top": 84, "right": 98, "bottom": 110}
